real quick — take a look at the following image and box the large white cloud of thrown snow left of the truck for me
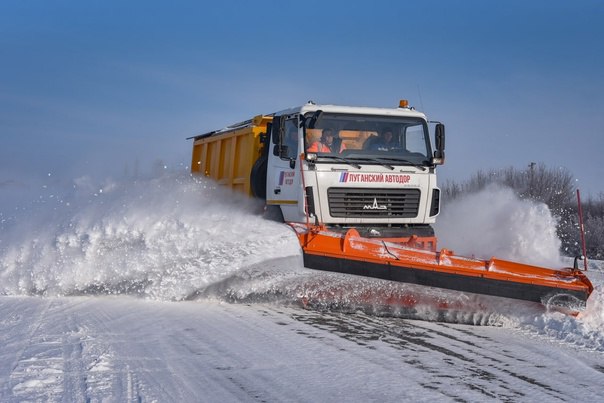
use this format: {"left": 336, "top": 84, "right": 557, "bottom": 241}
{"left": 0, "top": 174, "right": 300, "bottom": 300}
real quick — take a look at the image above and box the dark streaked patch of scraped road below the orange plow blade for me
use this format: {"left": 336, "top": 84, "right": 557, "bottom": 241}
{"left": 284, "top": 311, "right": 601, "bottom": 401}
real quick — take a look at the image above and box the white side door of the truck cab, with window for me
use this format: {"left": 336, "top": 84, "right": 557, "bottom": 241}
{"left": 266, "top": 114, "right": 302, "bottom": 221}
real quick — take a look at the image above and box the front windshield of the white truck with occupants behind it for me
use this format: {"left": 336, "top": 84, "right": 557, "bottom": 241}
{"left": 304, "top": 112, "right": 432, "bottom": 166}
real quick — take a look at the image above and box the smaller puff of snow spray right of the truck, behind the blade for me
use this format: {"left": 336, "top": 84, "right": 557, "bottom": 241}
{"left": 435, "top": 185, "right": 564, "bottom": 268}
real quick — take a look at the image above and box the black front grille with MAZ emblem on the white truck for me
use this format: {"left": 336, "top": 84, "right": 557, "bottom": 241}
{"left": 327, "top": 188, "right": 420, "bottom": 218}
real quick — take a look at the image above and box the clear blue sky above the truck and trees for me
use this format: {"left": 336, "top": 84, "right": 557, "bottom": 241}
{"left": 0, "top": 0, "right": 604, "bottom": 196}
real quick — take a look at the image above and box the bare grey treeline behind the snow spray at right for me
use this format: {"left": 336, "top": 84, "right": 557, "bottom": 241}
{"left": 442, "top": 164, "right": 604, "bottom": 260}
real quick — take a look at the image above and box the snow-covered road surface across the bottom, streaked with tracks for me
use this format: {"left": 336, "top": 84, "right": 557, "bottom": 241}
{"left": 0, "top": 296, "right": 604, "bottom": 402}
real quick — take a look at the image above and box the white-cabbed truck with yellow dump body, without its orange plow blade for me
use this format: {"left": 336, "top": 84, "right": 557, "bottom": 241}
{"left": 191, "top": 101, "right": 444, "bottom": 250}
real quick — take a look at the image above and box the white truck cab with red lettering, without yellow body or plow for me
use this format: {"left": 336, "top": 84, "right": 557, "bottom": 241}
{"left": 266, "top": 101, "right": 444, "bottom": 246}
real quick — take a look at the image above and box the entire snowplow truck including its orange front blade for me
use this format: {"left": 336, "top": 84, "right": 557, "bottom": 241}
{"left": 189, "top": 100, "right": 593, "bottom": 312}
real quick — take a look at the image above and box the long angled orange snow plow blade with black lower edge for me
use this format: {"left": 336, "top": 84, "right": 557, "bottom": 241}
{"left": 290, "top": 223, "right": 593, "bottom": 309}
